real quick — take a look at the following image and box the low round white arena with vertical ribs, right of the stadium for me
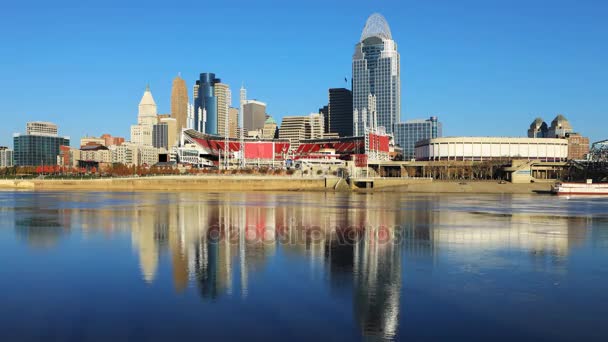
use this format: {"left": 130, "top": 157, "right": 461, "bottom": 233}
{"left": 415, "top": 137, "right": 568, "bottom": 161}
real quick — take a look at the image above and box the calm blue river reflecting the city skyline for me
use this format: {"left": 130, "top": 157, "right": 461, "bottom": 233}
{"left": 0, "top": 192, "right": 608, "bottom": 342}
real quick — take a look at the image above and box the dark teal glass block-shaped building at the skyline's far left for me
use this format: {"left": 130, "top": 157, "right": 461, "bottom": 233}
{"left": 13, "top": 122, "right": 70, "bottom": 166}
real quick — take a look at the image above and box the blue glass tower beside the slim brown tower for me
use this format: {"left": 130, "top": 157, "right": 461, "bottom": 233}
{"left": 194, "top": 73, "right": 221, "bottom": 134}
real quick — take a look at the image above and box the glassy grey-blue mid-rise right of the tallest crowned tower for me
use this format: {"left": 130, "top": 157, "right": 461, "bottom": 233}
{"left": 394, "top": 116, "right": 443, "bottom": 160}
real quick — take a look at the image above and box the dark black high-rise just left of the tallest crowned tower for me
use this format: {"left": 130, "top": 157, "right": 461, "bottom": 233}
{"left": 323, "top": 88, "right": 353, "bottom": 137}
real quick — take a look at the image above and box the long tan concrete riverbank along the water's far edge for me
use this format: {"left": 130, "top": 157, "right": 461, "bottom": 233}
{"left": 0, "top": 175, "right": 551, "bottom": 194}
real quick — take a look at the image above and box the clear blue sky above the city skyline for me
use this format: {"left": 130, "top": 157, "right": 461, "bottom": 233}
{"left": 0, "top": 0, "right": 608, "bottom": 146}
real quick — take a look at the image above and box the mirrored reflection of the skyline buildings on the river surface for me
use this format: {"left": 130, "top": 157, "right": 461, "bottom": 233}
{"left": 5, "top": 193, "right": 608, "bottom": 338}
